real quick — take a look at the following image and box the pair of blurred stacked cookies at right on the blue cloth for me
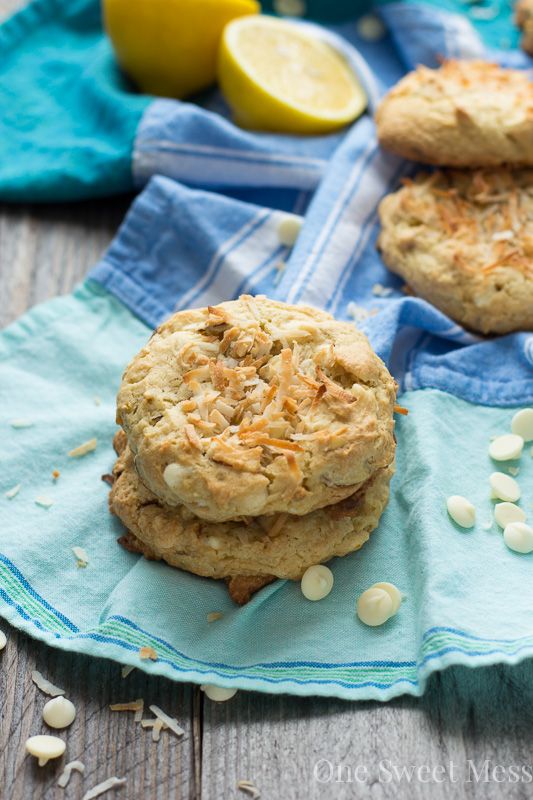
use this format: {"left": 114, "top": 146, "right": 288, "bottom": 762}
{"left": 376, "top": 61, "right": 533, "bottom": 334}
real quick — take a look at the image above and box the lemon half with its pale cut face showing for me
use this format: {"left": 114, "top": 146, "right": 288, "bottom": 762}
{"left": 218, "top": 16, "right": 367, "bottom": 134}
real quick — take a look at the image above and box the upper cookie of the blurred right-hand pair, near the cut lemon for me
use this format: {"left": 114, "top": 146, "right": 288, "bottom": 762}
{"left": 376, "top": 61, "right": 533, "bottom": 168}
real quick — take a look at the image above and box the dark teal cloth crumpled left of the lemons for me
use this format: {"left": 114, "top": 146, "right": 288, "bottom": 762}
{"left": 0, "top": 0, "right": 152, "bottom": 202}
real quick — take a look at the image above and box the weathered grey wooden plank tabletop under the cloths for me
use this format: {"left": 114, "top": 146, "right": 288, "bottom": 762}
{"left": 0, "top": 0, "right": 533, "bottom": 800}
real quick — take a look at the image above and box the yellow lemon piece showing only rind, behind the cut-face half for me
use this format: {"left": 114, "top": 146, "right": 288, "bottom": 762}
{"left": 103, "top": 0, "right": 260, "bottom": 98}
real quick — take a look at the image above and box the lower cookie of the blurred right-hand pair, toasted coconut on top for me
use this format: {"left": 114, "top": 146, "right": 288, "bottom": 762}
{"left": 378, "top": 168, "right": 533, "bottom": 334}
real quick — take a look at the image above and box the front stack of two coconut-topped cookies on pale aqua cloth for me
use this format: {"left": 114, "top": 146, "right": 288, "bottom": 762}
{"left": 110, "top": 296, "right": 396, "bottom": 603}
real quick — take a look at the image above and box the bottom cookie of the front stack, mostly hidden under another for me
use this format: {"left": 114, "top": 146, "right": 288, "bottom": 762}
{"left": 109, "top": 432, "right": 393, "bottom": 594}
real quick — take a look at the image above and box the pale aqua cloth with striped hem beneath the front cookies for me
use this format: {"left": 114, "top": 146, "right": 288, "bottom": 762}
{"left": 0, "top": 282, "right": 533, "bottom": 700}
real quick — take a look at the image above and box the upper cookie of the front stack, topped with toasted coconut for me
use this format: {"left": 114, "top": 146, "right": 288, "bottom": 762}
{"left": 117, "top": 296, "right": 396, "bottom": 522}
